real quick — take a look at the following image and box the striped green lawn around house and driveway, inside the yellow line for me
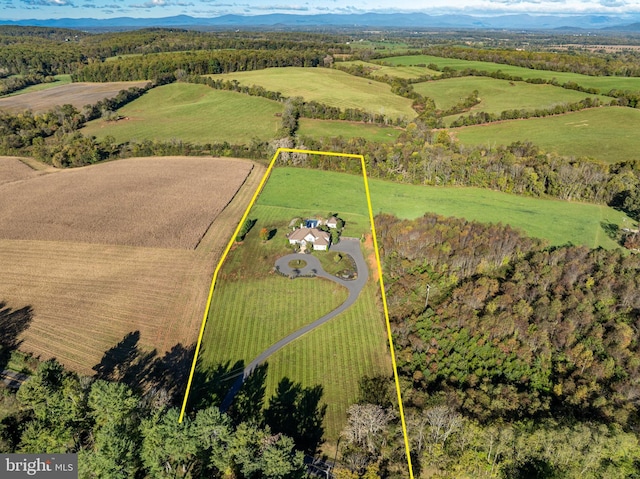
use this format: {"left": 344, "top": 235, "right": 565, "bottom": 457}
{"left": 199, "top": 163, "right": 391, "bottom": 441}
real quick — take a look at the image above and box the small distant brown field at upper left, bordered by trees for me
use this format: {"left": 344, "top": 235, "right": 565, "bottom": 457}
{"left": 0, "top": 81, "right": 147, "bottom": 112}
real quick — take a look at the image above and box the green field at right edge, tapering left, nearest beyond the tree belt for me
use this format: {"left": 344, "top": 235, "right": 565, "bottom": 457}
{"left": 451, "top": 107, "right": 640, "bottom": 163}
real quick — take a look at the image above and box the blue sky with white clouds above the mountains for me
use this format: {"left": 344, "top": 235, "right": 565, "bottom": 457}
{"left": 0, "top": 0, "right": 640, "bottom": 20}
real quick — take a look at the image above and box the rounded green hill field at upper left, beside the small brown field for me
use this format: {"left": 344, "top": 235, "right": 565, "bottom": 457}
{"left": 81, "top": 83, "right": 283, "bottom": 143}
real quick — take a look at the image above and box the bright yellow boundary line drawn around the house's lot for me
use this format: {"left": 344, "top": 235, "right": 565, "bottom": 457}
{"left": 178, "top": 148, "right": 414, "bottom": 479}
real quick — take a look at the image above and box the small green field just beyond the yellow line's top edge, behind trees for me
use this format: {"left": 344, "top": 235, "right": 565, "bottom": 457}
{"left": 298, "top": 118, "right": 401, "bottom": 142}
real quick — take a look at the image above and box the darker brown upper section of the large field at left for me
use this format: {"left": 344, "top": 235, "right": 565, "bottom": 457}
{"left": 0, "top": 157, "right": 253, "bottom": 249}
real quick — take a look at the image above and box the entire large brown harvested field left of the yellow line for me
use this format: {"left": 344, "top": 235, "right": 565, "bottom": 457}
{"left": 0, "top": 158, "right": 264, "bottom": 374}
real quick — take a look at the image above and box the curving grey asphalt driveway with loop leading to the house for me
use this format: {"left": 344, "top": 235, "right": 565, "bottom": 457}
{"left": 220, "top": 238, "right": 369, "bottom": 411}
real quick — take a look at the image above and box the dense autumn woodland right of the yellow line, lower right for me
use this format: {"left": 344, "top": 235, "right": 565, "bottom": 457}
{"left": 372, "top": 214, "right": 640, "bottom": 477}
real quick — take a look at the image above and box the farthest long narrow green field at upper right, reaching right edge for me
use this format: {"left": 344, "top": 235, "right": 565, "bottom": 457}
{"left": 382, "top": 55, "right": 640, "bottom": 93}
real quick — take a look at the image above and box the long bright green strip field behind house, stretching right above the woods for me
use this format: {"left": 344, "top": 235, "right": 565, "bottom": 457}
{"left": 260, "top": 167, "right": 632, "bottom": 248}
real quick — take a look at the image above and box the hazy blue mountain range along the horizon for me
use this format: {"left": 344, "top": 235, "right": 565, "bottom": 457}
{"left": 0, "top": 13, "right": 640, "bottom": 32}
